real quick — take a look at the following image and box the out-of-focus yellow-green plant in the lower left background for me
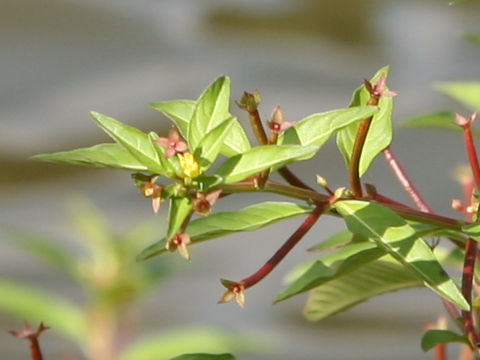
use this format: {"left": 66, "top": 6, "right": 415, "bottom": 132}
{"left": 0, "top": 198, "right": 253, "bottom": 360}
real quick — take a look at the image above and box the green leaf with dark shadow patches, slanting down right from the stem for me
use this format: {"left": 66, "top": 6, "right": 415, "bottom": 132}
{"left": 333, "top": 200, "right": 469, "bottom": 309}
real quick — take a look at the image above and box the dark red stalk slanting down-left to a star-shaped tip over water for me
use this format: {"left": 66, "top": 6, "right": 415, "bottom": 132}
{"left": 240, "top": 205, "right": 325, "bottom": 289}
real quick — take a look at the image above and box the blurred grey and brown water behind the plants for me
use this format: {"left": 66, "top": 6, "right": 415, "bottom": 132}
{"left": 0, "top": 0, "right": 480, "bottom": 360}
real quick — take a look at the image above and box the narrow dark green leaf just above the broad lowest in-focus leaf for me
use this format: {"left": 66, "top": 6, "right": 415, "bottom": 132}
{"left": 274, "top": 248, "right": 385, "bottom": 303}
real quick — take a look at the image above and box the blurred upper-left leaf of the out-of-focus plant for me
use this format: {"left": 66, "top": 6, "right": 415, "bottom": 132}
{"left": 5, "top": 230, "right": 77, "bottom": 278}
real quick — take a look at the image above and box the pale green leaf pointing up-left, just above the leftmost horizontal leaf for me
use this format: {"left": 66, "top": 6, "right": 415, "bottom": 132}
{"left": 90, "top": 111, "right": 165, "bottom": 174}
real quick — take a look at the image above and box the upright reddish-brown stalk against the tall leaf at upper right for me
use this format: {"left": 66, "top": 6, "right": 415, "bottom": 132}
{"left": 349, "top": 96, "right": 378, "bottom": 198}
